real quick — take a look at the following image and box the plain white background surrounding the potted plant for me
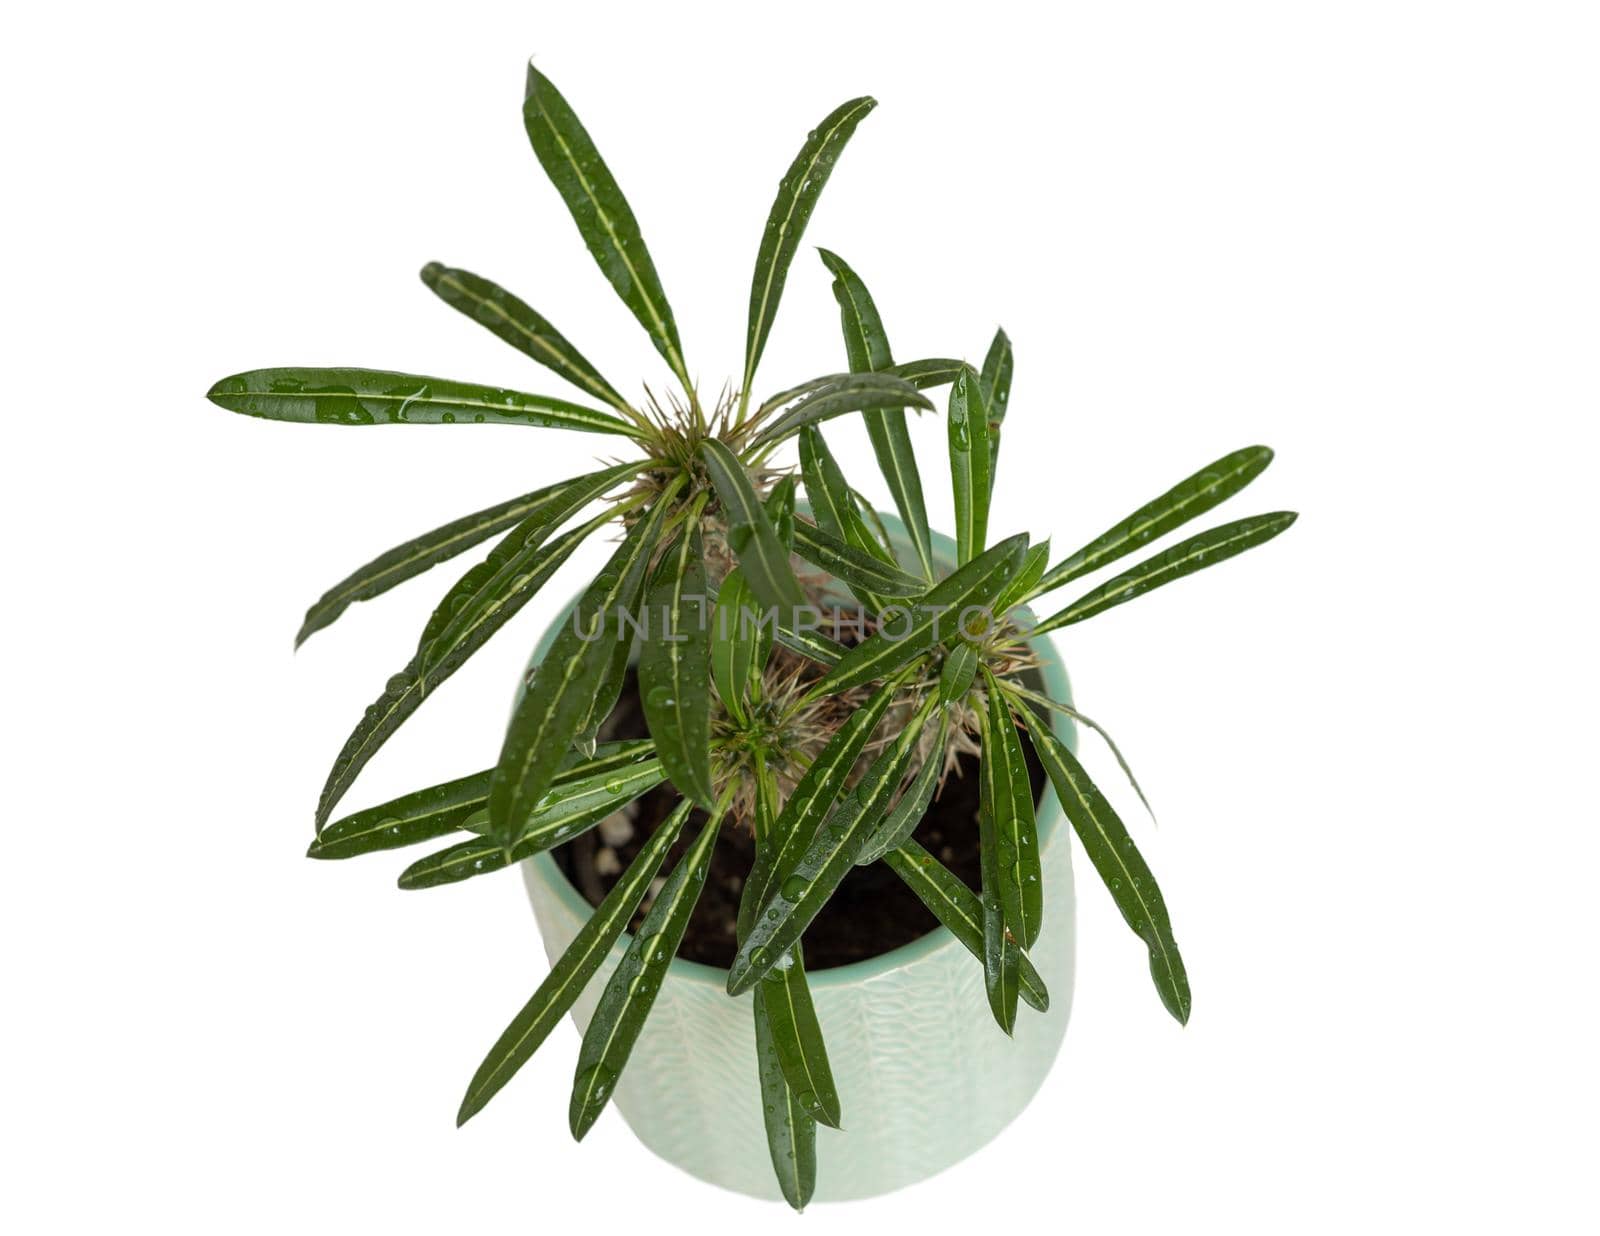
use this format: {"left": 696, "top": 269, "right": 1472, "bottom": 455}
{"left": 0, "top": 0, "right": 1600, "bottom": 1233}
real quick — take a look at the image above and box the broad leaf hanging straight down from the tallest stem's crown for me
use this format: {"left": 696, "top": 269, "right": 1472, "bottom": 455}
{"left": 638, "top": 525, "right": 715, "bottom": 807}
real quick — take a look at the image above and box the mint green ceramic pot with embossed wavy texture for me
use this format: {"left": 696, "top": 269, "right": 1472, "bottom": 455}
{"left": 522, "top": 516, "right": 1077, "bottom": 1202}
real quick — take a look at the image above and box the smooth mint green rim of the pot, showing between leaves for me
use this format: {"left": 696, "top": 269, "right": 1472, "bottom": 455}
{"left": 518, "top": 503, "right": 1077, "bottom": 991}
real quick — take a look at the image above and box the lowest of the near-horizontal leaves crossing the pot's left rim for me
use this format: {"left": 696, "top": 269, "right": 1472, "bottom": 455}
{"left": 400, "top": 759, "right": 666, "bottom": 890}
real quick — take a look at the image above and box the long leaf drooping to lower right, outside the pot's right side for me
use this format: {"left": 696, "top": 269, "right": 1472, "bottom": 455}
{"left": 1021, "top": 708, "right": 1190, "bottom": 1023}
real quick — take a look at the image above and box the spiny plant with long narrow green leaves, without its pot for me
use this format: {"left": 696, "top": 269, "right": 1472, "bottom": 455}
{"left": 210, "top": 67, "right": 1294, "bottom": 1207}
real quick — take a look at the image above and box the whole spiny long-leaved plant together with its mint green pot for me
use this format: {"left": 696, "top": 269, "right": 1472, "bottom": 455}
{"left": 210, "top": 67, "right": 1294, "bottom": 1207}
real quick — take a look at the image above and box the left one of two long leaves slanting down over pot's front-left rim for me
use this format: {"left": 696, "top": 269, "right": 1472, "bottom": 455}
{"left": 456, "top": 799, "right": 694, "bottom": 1127}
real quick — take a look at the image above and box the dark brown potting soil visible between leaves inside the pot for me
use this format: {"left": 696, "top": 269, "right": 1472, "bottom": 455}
{"left": 552, "top": 671, "right": 1045, "bottom": 970}
